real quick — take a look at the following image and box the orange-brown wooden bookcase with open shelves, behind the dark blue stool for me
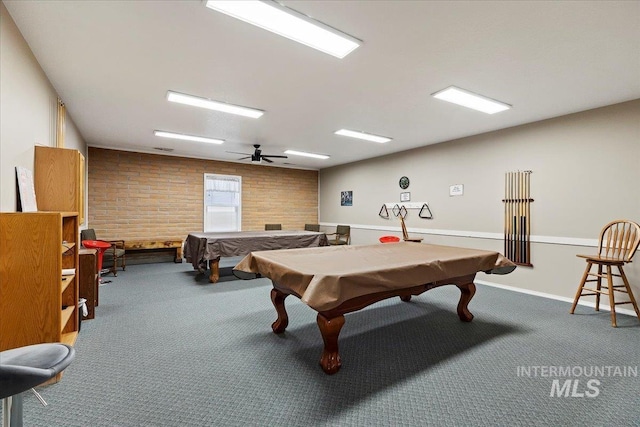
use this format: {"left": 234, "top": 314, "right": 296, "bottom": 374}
{"left": 0, "top": 212, "right": 80, "bottom": 351}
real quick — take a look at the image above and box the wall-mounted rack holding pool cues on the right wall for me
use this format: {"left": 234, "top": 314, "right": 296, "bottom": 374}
{"left": 502, "top": 171, "right": 533, "bottom": 266}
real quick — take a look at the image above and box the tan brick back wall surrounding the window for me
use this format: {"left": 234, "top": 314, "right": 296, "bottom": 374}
{"left": 87, "top": 147, "right": 318, "bottom": 240}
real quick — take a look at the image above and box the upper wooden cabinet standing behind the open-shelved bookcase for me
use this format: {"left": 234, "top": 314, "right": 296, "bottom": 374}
{"left": 33, "top": 146, "right": 85, "bottom": 224}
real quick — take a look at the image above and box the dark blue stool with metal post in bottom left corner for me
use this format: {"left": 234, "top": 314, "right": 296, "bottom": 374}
{"left": 0, "top": 343, "right": 75, "bottom": 427}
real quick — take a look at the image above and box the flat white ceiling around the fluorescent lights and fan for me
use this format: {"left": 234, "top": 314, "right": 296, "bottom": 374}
{"left": 4, "top": 0, "right": 640, "bottom": 169}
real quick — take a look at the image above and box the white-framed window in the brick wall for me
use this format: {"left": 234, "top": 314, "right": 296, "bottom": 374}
{"left": 204, "top": 173, "right": 242, "bottom": 232}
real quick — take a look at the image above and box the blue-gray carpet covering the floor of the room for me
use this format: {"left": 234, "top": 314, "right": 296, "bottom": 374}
{"left": 5, "top": 263, "right": 640, "bottom": 427}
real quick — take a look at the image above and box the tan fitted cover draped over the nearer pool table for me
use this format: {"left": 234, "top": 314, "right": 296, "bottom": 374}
{"left": 235, "top": 242, "right": 516, "bottom": 311}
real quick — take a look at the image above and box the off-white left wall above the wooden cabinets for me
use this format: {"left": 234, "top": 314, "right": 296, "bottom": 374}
{"left": 0, "top": 3, "right": 87, "bottom": 212}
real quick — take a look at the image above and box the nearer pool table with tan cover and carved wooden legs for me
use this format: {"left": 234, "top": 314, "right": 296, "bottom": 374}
{"left": 235, "top": 242, "right": 516, "bottom": 374}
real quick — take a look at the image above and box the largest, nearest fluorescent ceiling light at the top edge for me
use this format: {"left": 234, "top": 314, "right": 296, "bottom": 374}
{"left": 206, "top": 0, "right": 362, "bottom": 58}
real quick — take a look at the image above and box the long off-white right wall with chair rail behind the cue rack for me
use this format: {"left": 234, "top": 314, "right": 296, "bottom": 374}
{"left": 320, "top": 100, "right": 640, "bottom": 309}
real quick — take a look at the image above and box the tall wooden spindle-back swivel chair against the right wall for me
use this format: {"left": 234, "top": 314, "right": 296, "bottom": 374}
{"left": 570, "top": 220, "right": 640, "bottom": 328}
